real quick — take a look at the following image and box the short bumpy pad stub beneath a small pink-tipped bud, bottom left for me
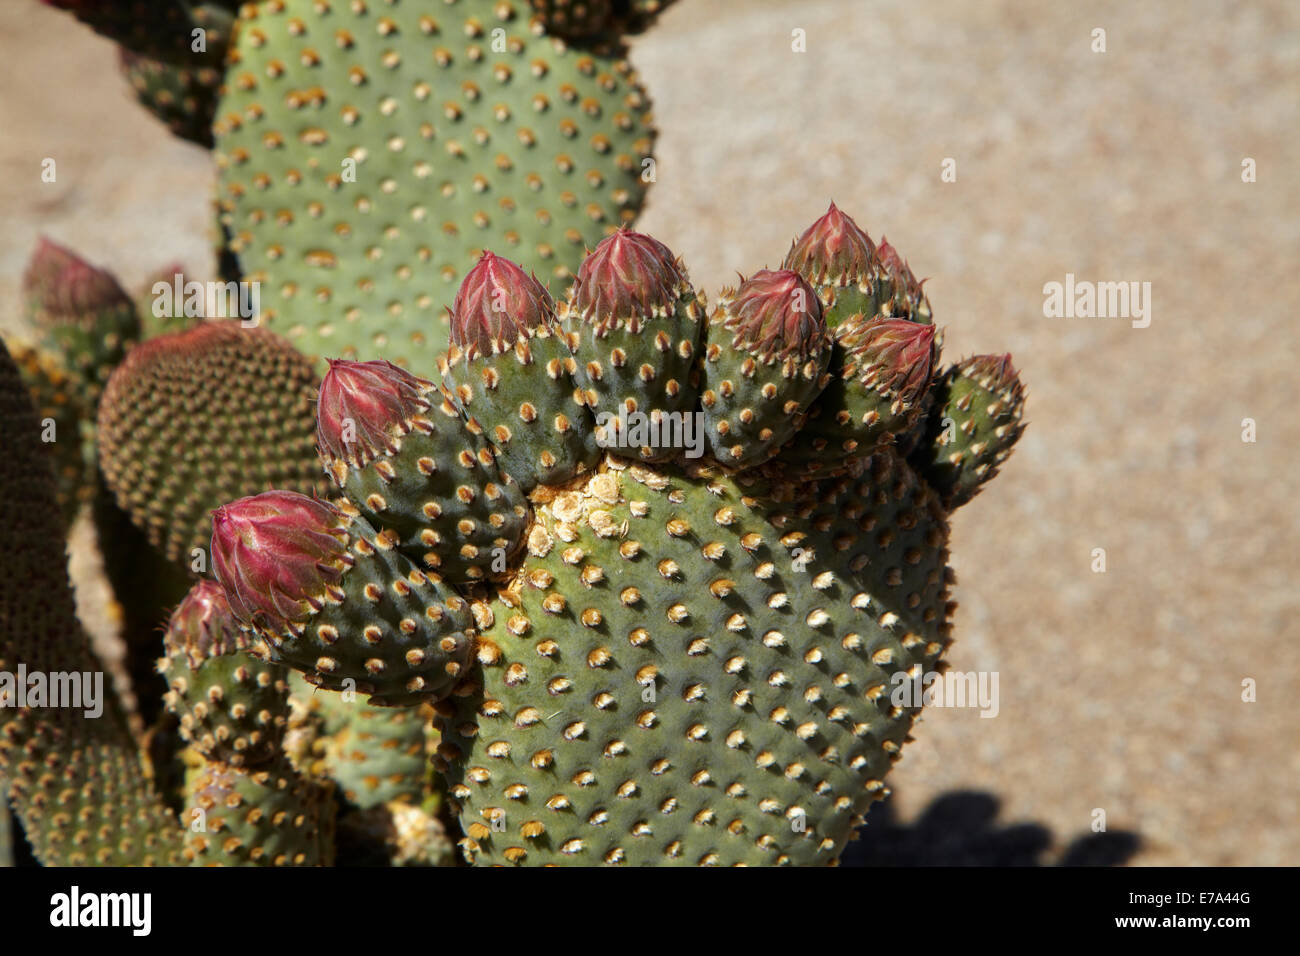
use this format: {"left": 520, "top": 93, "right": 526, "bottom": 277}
{"left": 181, "top": 762, "right": 334, "bottom": 866}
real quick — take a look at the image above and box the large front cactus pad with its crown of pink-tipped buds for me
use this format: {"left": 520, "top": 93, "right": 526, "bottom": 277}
{"left": 213, "top": 207, "right": 1023, "bottom": 865}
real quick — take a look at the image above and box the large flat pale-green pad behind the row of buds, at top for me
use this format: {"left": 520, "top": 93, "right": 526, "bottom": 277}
{"left": 216, "top": 0, "right": 653, "bottom": 371}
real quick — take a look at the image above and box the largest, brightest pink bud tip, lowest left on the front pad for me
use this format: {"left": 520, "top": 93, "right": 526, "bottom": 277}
{"left": 212, "top": 492, "right": 350, "bottom": 631}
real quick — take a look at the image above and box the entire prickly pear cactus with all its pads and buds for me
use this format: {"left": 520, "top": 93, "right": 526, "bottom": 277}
{"left": 10, "top": 0, "right": 1023, "bottom": 865}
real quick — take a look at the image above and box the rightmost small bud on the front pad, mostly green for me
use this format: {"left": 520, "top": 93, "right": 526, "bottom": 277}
{"left": 909, "top": 355, "right": 1024, "bottom": 509}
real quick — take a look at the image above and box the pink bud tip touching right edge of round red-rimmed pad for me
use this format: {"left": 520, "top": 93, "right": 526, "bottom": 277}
{"left": 316, "top": 359, "right": 434, "bottom": 467}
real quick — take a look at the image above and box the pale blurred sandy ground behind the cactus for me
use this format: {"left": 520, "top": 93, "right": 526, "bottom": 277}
{"left": 0, "top": 0, "right": 1300, "bottom": 864}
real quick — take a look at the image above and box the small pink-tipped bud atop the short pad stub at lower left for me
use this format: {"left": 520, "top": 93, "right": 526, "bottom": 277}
{"left": 159, "top": 580, "right": 289, "bottom": 767}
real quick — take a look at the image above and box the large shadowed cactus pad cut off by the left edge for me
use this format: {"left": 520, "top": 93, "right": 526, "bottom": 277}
{"left": 0, "top": 346, "right": 181, "bottom": 866}
